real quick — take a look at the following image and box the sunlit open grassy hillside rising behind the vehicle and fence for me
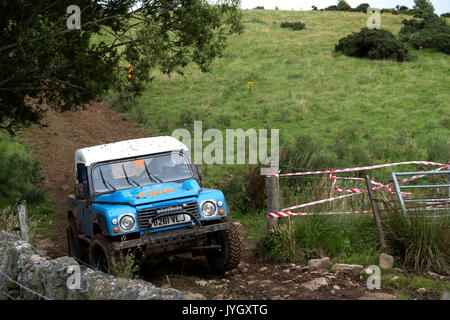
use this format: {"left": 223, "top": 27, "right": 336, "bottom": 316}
{"left": 120, "top": 10, "right": 450, "bottom": 174}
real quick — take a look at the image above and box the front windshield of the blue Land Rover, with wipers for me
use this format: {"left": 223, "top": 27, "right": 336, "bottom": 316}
{"left": 92, "top": 153, "right": 192, "bottom": 193}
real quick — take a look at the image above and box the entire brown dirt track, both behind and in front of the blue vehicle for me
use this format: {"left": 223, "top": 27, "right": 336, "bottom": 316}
{"left": 20, "top": 103, "right": 438, "bottom": 299}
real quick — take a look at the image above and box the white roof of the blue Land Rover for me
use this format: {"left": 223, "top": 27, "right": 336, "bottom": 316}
{"left": 75, "top": 136, "right": 189, "bottom": 167}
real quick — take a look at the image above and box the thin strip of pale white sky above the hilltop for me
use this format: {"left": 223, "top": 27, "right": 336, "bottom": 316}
{"left": 241, "top": 0, "right": 450, "bottom": 14}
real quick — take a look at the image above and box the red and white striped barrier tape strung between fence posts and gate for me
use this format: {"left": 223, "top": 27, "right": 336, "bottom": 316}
{"left": 267, "top": 161, "right": 450, "bottom": 218}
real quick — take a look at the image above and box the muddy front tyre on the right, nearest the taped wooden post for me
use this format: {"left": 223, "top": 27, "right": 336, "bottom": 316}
{"left": 206, "top": 223, "right": 241, "bottom": 273}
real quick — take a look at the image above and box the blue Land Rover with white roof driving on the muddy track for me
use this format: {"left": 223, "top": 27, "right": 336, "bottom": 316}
{"left": 67, "top": 137, "right": 241, "bottom": 272}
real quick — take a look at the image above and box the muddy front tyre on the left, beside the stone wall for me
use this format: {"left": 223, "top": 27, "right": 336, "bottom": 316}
{"left": 89, "top": 234, "right": 113, "bottom": 273}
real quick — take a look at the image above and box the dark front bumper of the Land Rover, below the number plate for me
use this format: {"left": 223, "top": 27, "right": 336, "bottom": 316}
{"left": 111, "top": 222, "right": 230, "bottom": 251}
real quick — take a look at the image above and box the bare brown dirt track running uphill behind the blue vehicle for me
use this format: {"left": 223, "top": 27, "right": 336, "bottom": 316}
{"left": 20, "top": 103, "right": 146, "bottom": 252}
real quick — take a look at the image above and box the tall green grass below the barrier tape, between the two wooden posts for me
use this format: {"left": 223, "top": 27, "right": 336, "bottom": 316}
{"left": 257, "top": 212, "right": 381, "bottom": 265}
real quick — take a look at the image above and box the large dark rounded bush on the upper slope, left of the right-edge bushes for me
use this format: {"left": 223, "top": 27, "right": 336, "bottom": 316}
{"left": 335, "top": 28, "right": 410, "bottom": 61}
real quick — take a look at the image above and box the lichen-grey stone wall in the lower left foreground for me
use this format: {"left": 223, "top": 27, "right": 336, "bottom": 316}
{"left": 0, "top": 231, "right": 202, "bottom": 300}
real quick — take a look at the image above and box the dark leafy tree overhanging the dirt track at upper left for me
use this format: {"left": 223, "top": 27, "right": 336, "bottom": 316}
{"left": 0, "top": 0, "right": 242, "bottom": 133}
